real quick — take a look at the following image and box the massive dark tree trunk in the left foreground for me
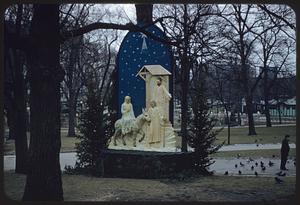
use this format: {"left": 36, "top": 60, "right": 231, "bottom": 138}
{"left": 23, "top": 4, "right": 64, "bottom": 201}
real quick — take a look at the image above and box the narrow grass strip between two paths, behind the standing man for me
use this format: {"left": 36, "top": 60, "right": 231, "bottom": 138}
{"left": 211, "top": 148, "right": 296, "bottom": 158}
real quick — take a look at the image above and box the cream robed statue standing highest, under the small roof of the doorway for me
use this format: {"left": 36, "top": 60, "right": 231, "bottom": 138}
{"left": 151, "top": 77, "right": 172, "bottom": 119}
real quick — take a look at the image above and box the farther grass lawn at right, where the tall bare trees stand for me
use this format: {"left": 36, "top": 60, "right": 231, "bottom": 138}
{"left": 216, "top": 125, "right": 296, "bottom": 144}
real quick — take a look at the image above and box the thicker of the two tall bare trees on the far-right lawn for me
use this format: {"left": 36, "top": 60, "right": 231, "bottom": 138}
{"left": 219, "top": 4, "right": 270, "bottom": 135}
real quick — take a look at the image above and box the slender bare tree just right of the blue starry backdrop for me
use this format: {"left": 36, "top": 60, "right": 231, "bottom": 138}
{"left": 157, "top": 4, "right": 218, "bottom": 152}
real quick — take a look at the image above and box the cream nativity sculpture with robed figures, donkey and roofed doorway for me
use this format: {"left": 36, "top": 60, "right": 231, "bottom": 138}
{"left": 109, "top": 65, "right": 176, "bottom": 152}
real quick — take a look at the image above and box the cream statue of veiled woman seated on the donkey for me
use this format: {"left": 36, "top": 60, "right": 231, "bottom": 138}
{"left": 121, "top": 96, "right": 135, "bottom": 135}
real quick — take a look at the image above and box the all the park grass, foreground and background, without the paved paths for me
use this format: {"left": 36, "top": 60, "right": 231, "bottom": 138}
{"left": 4, "top": 125, "right": 296, "bottom": 204}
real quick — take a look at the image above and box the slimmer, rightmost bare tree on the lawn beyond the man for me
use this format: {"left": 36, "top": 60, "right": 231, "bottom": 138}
{"left": 255, "top": 5, "right": 295, "bottom": 127}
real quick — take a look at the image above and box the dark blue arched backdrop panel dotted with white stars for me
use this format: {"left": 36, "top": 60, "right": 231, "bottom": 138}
{"left": 117, "top": 25, "right": 173, "bottom": 119}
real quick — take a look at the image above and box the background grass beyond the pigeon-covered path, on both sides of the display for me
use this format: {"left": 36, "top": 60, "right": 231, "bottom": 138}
{"left": 4, "top": 125, "right": 296, "bottom": 157}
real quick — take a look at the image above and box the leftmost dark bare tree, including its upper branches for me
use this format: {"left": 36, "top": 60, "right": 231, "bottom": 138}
{"left": 5, "top": 4, "right": 31, "bottom": 173}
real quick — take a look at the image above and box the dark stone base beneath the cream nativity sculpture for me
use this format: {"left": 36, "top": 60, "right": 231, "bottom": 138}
{"left": 104, "top": 149, "right": 192, "bottom": 178}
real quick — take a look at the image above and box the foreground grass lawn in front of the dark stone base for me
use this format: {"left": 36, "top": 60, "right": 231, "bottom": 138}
{"left": 4, "top": 172, "right": 296, "bottom": 202}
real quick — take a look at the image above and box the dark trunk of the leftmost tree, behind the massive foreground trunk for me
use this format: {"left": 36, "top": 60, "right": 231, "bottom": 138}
{"left": 5, "top": 5, "right": 28, "bottom": 174}
